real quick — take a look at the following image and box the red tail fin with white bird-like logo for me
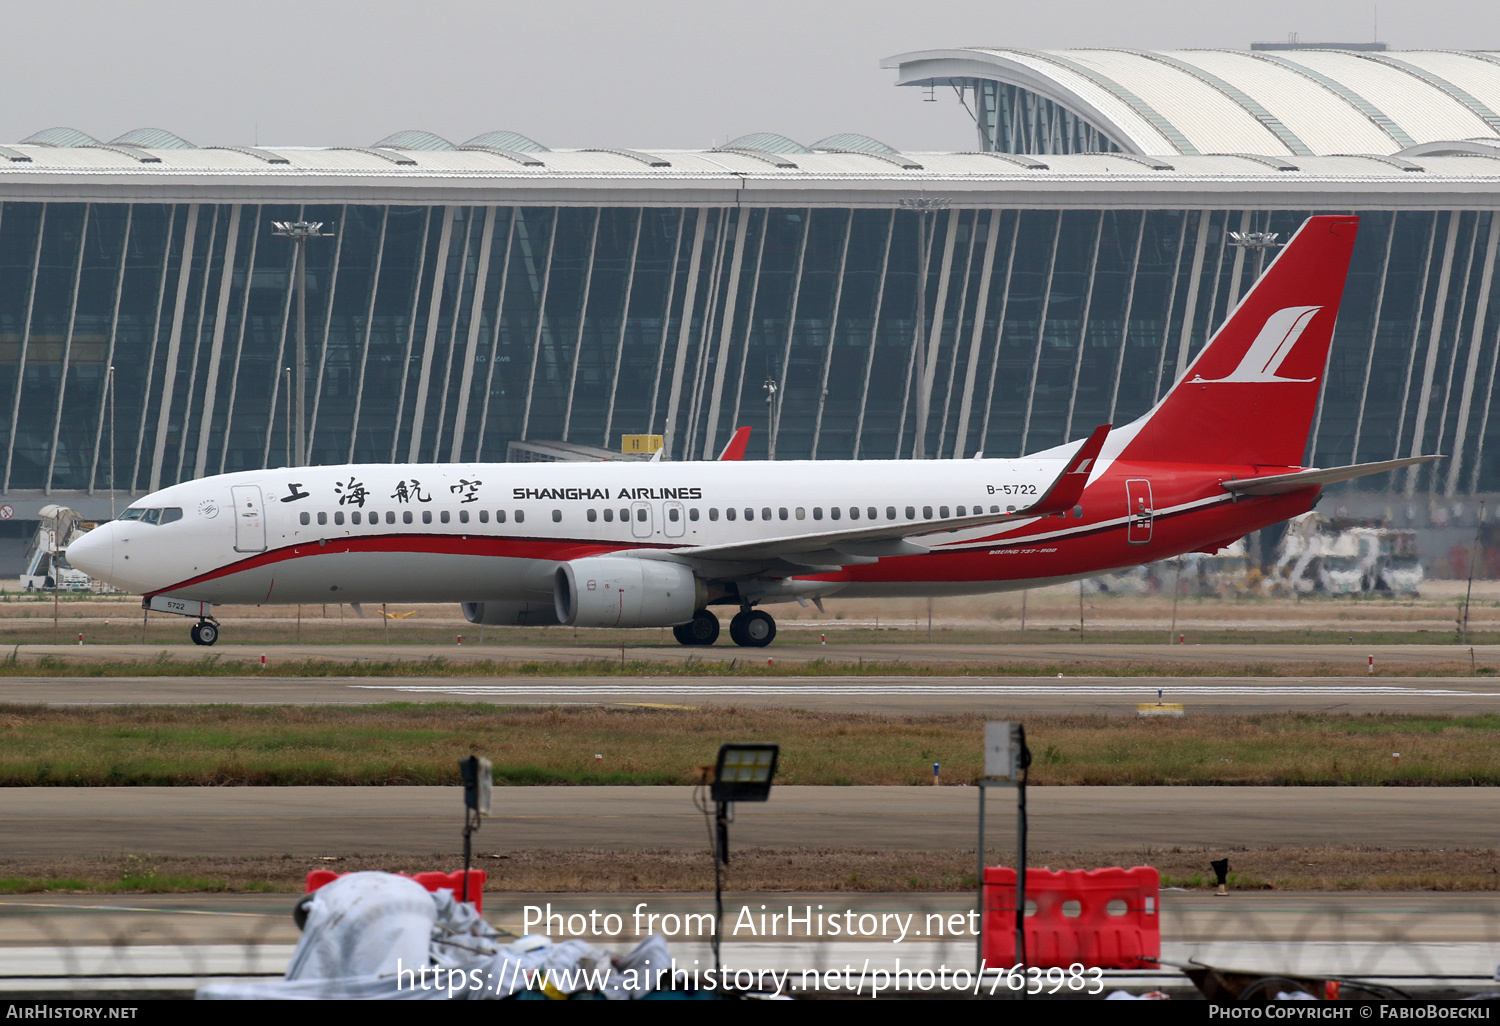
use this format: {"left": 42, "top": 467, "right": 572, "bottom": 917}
{"left": 1115, "top": 216, "right": 1359, "bottom": 467}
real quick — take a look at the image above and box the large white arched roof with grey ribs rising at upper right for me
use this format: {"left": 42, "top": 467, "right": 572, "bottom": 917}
{"left": 882, "top": 47, "right": 1500, "bottom": 158}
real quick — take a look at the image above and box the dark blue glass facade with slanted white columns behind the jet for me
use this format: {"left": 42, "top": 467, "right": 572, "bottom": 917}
{"left": 0, "top": 201, "right": 1500, "bottom": 495}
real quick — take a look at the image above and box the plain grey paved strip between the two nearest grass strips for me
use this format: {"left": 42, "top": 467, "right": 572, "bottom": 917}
{"left": 0, "top": 786, "right": 1500, "bottom": 860}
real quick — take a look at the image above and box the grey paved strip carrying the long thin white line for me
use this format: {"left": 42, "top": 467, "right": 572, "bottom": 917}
{"left": 0, "top": 677, "right": 1500, "bottom": 716}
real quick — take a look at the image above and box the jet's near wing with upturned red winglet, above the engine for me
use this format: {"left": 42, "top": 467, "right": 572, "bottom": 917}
{"left": 657, "top": 425, "right": 1110, "bottom": 569}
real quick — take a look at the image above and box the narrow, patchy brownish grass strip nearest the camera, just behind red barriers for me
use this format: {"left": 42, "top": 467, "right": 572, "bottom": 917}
{"left": 0, "top": 846, "right": 1500, "bottom": 908}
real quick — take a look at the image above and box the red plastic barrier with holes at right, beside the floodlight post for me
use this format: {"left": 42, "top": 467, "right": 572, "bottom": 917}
{"left": 981, "top": 866, "right": 1161, "bottom": 969}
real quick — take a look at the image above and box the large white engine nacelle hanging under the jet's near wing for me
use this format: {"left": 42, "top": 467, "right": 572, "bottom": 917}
{"left": 552, "top": 557, "right": 708, "bottom": 627}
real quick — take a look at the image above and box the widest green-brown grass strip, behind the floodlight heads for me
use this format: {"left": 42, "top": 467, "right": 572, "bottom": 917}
{"left": 0, "top": 704, "right": 1500, "bottom": 786}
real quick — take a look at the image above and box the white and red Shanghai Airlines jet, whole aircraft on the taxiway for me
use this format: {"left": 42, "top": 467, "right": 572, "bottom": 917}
{"left": 68, "top": 216, "right": 1436, "bottom": 647}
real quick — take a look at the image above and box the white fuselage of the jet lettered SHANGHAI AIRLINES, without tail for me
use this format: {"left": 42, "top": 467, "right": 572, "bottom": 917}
{"left": 71, "top": 453, "right": 1061, "bottom": 605}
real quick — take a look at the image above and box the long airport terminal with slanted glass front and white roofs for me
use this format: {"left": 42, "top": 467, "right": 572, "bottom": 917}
{"left": 0, "top": 50, "right": 1500, "bottom": 561}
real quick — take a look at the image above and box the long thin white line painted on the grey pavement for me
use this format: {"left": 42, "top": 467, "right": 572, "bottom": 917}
{"left": 350, "top": 684, "right": 1500, "bottom": 705}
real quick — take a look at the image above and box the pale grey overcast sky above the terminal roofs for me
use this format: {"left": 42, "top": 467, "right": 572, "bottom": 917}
{"left": 0, "top": 0, "right": 1500, "bottom": 150}
